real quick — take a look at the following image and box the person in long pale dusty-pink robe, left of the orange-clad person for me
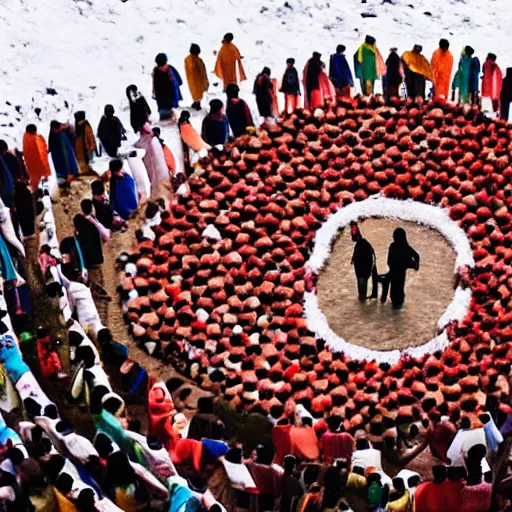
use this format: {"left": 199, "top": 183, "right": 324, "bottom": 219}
{"left": 135, "top": 123, "right": 170, "bottom": 199}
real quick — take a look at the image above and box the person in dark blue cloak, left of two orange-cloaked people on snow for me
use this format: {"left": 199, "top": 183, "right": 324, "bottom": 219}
{"left": 152, "top": 53, "right": 183, "bottom": 121}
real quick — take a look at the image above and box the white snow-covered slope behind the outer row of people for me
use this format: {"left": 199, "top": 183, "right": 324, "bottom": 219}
{"left": 0, "top": 0, "right": 512, "bottom": 152}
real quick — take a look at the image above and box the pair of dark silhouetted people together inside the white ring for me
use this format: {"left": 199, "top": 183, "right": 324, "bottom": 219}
{"left": 351, "top": 224, "right": 420, "bottom": 309}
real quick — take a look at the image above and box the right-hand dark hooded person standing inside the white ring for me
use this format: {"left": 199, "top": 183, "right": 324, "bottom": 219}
{"left": 388, "top": 228, "right": 420, "bottom": 308}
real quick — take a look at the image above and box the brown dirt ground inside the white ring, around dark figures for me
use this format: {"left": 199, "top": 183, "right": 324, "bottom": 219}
{"left": 317, "top": 219, "right": 455, "bottom": 350}
